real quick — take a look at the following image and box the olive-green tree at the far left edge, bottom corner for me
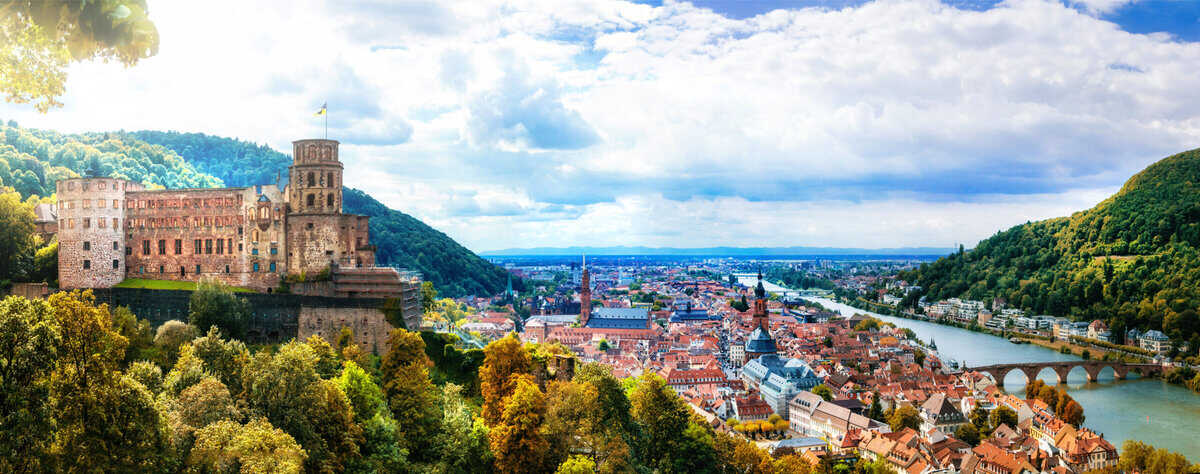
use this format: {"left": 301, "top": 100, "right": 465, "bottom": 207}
{"left": 0, "top": 296, "right": 61, "bottom": 472}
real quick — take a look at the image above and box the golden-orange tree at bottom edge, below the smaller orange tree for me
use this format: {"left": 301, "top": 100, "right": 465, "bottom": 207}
{"left": 488, "top": 374, "right": 550, "bottom": 473}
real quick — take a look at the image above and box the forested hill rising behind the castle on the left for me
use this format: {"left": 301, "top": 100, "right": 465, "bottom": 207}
{"left": 0, "top": 121, "right": 520, "bottom": 296}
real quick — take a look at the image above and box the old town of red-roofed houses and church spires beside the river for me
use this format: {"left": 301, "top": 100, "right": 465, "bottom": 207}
{"left": 425, "top": 259, "right": 1132, "bottom": 473}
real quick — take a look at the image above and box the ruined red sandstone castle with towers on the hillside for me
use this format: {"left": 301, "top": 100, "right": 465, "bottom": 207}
{"left": 56, "top": 139, "right": 374, "bottom": 290}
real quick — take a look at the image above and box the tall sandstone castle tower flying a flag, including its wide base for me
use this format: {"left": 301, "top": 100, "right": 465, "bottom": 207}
{"left": 287, "top": 139, "right": 348, "bottom": 275}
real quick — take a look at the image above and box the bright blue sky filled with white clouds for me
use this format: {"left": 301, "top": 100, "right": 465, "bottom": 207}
{"left": 0, "top": 0, "right": 1200, "bottom": 252}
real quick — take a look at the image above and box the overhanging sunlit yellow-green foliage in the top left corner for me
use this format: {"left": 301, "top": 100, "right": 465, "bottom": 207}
{"left": 0, "top": 0, "right": 158, "bottom": 113}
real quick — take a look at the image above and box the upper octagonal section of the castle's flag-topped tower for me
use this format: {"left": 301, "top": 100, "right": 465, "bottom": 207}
{"left": 288, "top": 138, "right": 342, "bottom": 214}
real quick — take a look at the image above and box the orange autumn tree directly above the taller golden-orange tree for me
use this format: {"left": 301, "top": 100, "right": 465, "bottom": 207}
{"left": 479, "top": 335, "right": 533, "bottom": 426}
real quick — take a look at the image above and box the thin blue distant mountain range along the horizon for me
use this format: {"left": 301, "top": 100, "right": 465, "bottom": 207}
{"left": 479, "top": 246, "right": 956, "bottom": 257}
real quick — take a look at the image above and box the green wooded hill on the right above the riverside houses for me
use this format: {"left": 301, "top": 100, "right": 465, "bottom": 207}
{"left": 901, "top": 149, "right": 1200, "bottom": 352}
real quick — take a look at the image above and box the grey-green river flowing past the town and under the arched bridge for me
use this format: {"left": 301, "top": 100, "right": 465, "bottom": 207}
{"left": 812, "top": 298, "right": 1200, "bottom": 462}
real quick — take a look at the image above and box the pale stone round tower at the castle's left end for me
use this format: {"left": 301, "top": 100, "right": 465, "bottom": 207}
{"left": 56, "top": 178, "right": 140, "bottom": 288}
